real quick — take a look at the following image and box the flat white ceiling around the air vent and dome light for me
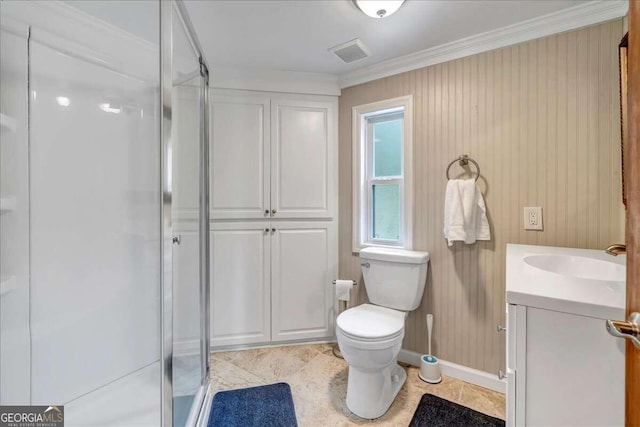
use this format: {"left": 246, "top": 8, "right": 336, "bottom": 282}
{"left": 185, "top": 0, "right": 585, "bottom": 75}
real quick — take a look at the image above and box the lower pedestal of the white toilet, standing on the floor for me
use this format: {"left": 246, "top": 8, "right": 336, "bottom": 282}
{"left": 347, "top": 361, "right": 407, "bottom": 420}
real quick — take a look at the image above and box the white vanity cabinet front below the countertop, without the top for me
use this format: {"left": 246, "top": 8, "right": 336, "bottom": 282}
{"left": 507, "top": 304, "right": 625, "bottom": 426}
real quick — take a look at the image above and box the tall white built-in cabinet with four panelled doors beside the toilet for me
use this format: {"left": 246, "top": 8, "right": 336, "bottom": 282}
{"left": 211, "top": 90, "right": 337, "bottom": 348}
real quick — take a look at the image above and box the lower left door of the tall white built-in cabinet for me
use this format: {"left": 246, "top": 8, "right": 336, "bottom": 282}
{"left": 211, "top": 222, "right": 271, "bottom": 347}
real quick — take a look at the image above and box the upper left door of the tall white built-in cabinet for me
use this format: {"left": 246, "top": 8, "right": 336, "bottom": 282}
{"left": 210, "top": 92, "right": 270, "bottom": 219}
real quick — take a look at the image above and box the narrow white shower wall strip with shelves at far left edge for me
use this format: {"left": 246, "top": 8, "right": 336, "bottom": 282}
{"left": 0, "top": 25, "right": 30, "bottom": 405}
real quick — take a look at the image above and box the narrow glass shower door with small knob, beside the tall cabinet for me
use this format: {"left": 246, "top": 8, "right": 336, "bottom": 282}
{"left": 167, "top": 2, "right": 209, "bottom": 426}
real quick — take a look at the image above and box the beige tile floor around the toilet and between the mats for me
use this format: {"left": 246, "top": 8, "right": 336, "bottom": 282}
{"left": 211, "top": 344, "right": 505, "bottom": 427}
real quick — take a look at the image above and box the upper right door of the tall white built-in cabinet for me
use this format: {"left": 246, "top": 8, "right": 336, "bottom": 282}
{"left": 271, "top": 99, "right": 336, "bottom": 218}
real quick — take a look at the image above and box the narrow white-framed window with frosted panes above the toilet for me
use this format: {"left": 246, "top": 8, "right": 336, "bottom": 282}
{"left": 353, "top": 96, "right": 413, "bottom": 252}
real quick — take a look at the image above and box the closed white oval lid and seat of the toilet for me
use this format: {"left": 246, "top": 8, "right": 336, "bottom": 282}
{"left": 336, "top": 304, "right": 405, "bottom": 339}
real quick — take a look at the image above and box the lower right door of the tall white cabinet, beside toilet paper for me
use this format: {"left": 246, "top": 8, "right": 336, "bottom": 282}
{"left": 271, "top": 222, "right": 337, "bottom": 342}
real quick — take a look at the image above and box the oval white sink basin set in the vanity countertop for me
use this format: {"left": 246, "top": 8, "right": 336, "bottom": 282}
{"left": 524, "top": 254, "right": 626, "bottom": 282}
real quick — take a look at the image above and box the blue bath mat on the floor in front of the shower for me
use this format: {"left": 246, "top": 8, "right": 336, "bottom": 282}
{"left": 207, "top": 383, "right": 298, "bottom": 427}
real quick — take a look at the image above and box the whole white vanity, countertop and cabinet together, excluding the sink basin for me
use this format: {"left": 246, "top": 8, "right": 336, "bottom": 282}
{"left": 507, "top": 245, "right": 625, "bottom": 426}
